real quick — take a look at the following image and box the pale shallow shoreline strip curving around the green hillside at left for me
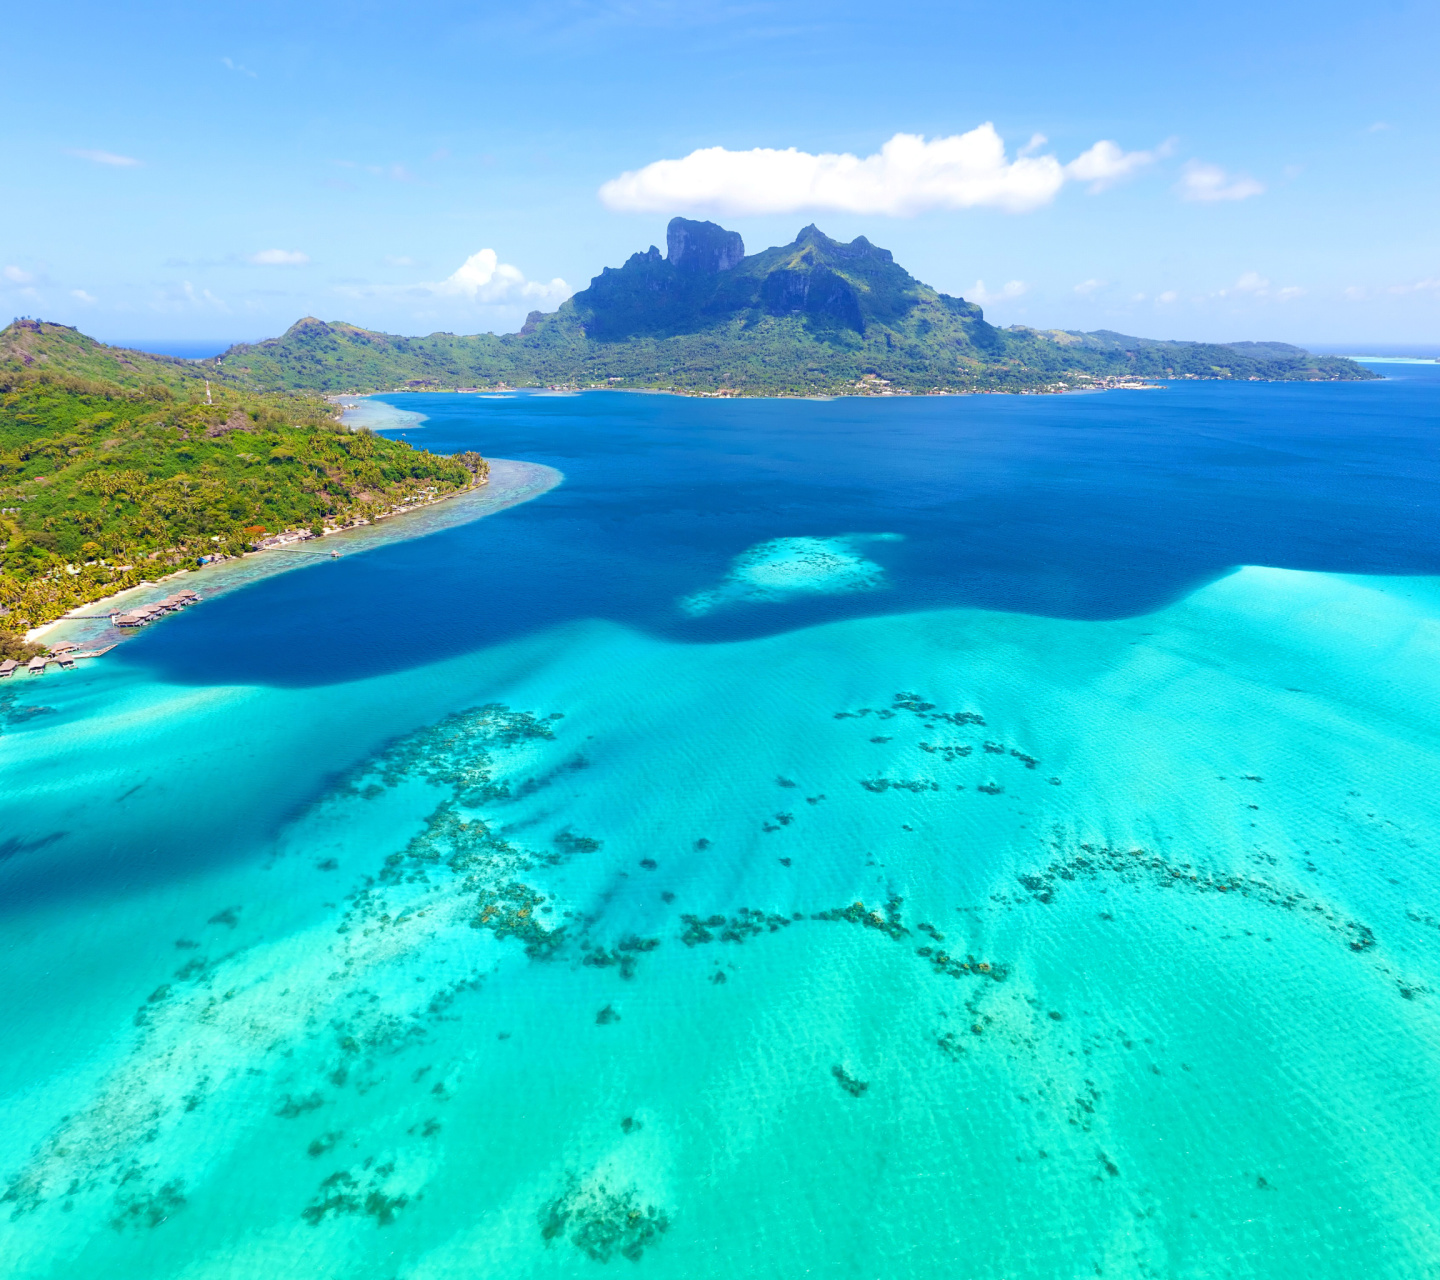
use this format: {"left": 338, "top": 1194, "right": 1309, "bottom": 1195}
{"left": 26, "top": 458, "right": 564, "bottom": 648}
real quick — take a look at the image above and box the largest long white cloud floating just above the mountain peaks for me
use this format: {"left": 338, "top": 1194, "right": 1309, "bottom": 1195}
{"left": 599, "top": 124, "right": 1149, "bottom": 217}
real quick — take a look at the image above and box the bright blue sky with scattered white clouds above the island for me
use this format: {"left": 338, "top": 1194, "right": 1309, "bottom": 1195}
{"left": 0, "top": 0, "right": 1440, "bottom": 348}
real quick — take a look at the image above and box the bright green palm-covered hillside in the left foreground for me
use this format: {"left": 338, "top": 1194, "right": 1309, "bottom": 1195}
{"left": 0, "top": 339, "right": 488, "bottom": 624}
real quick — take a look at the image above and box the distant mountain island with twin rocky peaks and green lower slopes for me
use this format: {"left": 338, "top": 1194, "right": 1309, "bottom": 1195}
{"left": 204, "top": 217, "right": 1374, "bottom": 395}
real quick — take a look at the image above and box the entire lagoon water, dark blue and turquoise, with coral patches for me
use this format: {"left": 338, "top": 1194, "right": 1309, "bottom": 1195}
{"left": 0, "top": 364, "right": 1440, "bottom": 1280}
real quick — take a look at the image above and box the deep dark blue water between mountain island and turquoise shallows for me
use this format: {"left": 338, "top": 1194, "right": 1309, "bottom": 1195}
{"left": 125, "top": 366, "right": 1440, "bottom": 685}
